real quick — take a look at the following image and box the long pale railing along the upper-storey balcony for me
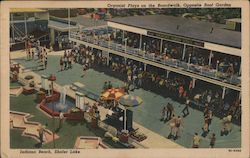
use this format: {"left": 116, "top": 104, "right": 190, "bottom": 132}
{"left": 70, "top": 32, "right": 241, "bottom": 86}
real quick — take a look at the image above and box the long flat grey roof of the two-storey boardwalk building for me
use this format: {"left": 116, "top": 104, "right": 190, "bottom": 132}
{"left": 109, "top": 15, "right": 241, "bottom": 48}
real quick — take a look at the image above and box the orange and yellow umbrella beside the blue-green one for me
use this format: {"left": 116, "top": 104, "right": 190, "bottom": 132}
{"left": 101, "top": 88, "right": 125, "bottom": 100}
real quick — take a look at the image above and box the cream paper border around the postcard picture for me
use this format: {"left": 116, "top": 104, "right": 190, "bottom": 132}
{"left": 0, "top": 0, "right": 250, "bottom": 158}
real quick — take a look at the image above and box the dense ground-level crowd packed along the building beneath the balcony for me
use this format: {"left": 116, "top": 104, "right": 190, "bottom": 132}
{"left": 67, "top": 46, "right": 241, "bottom": 122}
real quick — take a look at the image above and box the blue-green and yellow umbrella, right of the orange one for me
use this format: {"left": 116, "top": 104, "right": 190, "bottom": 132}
{"left": 119, "top": 95, "right": 142, "bottom": 106}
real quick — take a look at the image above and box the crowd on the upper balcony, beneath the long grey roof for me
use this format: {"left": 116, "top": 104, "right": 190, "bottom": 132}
{"left": 75, "top": 29, "right": 241, "bottom": 78}
